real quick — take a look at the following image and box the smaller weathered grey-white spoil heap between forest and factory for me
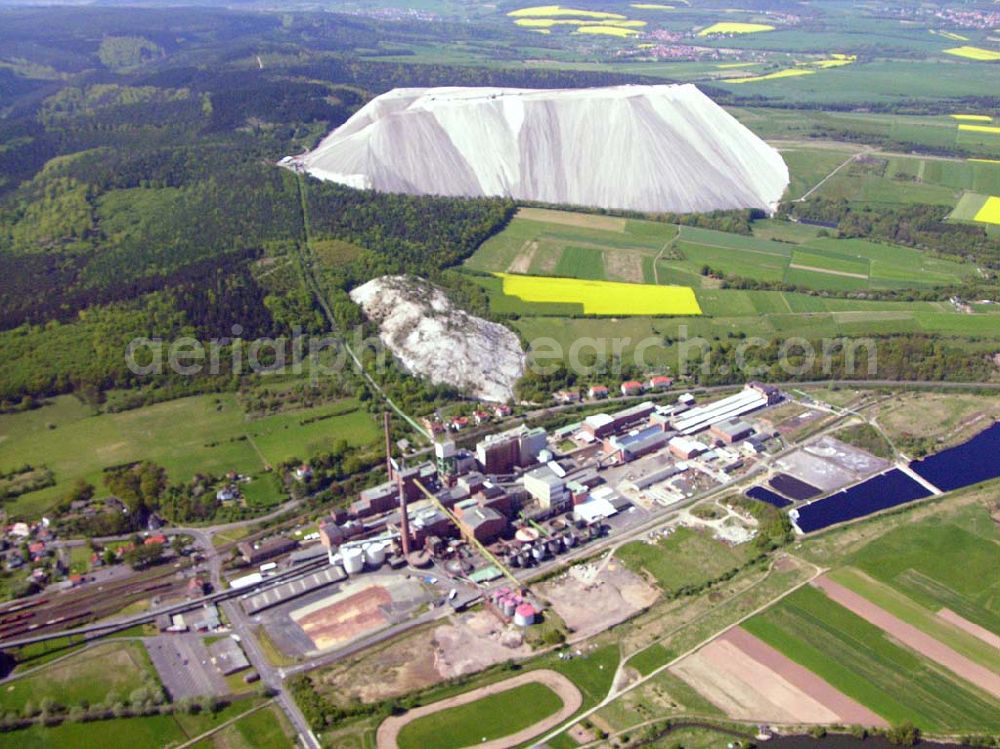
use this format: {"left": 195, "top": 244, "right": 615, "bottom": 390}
{"left": 351, "top": 276, "right": 524, "bottom": 403}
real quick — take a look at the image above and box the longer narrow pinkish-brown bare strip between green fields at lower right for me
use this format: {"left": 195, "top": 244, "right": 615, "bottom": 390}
{"left": 813, "top": 577, "right": 1000, "bottom": 697}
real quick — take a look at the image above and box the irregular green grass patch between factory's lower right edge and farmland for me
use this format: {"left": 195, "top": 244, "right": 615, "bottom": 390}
{"left": 616, "top": 527, "right": 749, "bottom": 593}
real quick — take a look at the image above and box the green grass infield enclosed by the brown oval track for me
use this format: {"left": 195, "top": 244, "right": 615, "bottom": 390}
{"left": 399, "top": 683, "right": 563, "bottom": 749}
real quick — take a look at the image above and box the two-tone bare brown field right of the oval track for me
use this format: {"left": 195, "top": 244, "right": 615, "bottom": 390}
{"left": 671, "top": 627, "right": 886, "bottom": 726}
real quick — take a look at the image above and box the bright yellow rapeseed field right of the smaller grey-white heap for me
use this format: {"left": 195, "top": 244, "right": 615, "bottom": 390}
{"left": 495, "top": 273, "right": 701, "bottom": 316}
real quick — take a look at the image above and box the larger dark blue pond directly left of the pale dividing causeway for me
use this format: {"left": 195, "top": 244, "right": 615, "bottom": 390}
{"left": 792, "top": 468, "right": 930, "bottom": 533}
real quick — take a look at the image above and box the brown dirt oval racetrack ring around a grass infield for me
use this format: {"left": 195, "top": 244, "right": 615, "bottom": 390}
{"left": 375, "top": 669, "right": 583, "bottom": 749}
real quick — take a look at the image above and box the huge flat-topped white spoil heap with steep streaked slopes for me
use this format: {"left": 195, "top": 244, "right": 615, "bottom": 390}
{"left": 292, "top": 84, "right": 788, "bottom": 213}
